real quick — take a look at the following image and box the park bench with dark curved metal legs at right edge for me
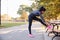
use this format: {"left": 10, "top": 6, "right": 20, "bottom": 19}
{"left": 48, "top": 21, "right": 60, "bottom": 40}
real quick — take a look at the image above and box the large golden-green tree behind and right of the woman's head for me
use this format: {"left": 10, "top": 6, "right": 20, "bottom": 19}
{"left": 32, "top": 0, "right": 60, "bottom": 19}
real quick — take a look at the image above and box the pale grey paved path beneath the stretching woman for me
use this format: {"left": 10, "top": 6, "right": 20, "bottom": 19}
{"left": 0, "top": 23, "right": 60, "bottom": 40}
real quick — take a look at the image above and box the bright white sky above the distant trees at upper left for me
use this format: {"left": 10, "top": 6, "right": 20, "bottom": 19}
{"left": 1, "top": 0, "right": 33, "bottom": 18}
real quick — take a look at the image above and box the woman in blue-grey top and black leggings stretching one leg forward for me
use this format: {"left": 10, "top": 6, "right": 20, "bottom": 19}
{"left": 28, "top": 7, "right": 52, "bottom": 37}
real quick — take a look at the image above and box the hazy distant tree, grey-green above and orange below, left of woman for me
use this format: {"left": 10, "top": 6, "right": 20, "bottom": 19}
{"left": 17, "top": 5, "right": 32, "bottom": 21}
